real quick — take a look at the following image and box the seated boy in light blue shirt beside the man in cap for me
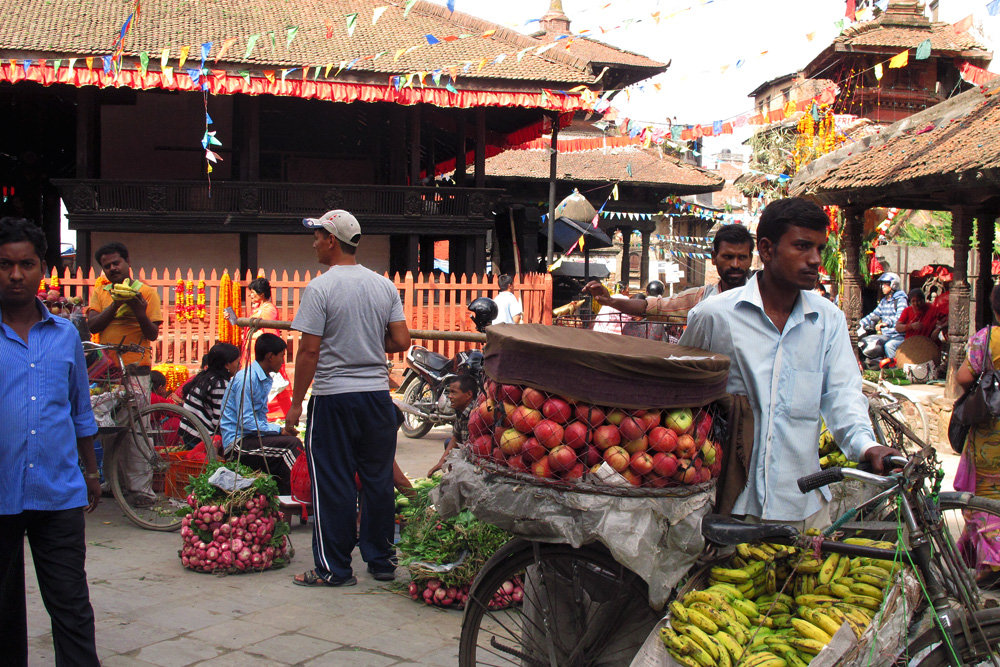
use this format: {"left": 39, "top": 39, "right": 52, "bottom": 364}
{"left": 219, "top": 333, "right": 302, "bottom": 495}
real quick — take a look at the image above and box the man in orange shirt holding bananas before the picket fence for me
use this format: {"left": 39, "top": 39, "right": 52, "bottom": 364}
{"left": 87, "top": 243, "right": 163, "bottom": 367}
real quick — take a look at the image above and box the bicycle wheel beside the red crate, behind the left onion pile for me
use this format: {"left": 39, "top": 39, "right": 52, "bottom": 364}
{"left": 106, "top": 403, "right": 216, "bottom": 531}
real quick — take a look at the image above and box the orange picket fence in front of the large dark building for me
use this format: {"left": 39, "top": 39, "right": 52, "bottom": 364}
{"left": 53, "top": 269, "right": 552, "bottom": 380}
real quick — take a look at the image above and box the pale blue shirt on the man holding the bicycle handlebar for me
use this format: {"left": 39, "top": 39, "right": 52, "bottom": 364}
{"left": 680, "top": 276, "right": 878, "bottom": 521}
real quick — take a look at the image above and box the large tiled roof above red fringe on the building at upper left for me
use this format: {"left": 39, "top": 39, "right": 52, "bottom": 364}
{"left": 0, "top": 0, "right": 624, "bottom": 85}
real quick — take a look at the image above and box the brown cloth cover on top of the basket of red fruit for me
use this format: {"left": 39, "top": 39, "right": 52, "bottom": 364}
{"left": 484, "top": 324, "right": 729, "bottom": 410}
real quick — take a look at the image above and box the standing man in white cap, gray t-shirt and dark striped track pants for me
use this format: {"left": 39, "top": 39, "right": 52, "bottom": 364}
{"left": 285, "top": 210, "right": 410, "bottom": 586}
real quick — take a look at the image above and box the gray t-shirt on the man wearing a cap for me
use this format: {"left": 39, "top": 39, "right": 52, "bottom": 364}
{"left": 292, "top": 264, "right": 406, "bottom": 396}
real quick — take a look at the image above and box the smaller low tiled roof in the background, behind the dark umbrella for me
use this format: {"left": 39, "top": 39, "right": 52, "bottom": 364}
{"left": 470, "top": 146, "right": 725, "bottom": 194}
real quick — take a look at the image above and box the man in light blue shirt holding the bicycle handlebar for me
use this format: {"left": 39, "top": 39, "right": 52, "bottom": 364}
{"left": 680, "top": 198, "right": 898, "bottom": 529}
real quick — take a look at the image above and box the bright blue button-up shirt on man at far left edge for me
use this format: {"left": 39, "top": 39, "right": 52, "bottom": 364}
{"left": 0, "top": 301, "right": 97, "bottom": 514}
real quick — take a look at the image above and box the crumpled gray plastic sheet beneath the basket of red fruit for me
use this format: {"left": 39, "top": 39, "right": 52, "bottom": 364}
{"left": 432, "top": 450, "right": 715, "bottom": 609}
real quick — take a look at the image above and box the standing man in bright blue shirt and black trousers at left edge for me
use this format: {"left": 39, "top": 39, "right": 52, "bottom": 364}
{"left": 0, "top": 218, "right": 101, "bottom": 665}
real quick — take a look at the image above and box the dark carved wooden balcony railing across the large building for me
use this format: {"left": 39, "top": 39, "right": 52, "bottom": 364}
{"left": 52, "top": 179, "right": 504, "bottom": 234}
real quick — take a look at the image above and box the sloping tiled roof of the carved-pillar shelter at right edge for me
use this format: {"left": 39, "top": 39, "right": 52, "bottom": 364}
{"left": 791, "top": 78, "right": 1000, "bottom": 201}
